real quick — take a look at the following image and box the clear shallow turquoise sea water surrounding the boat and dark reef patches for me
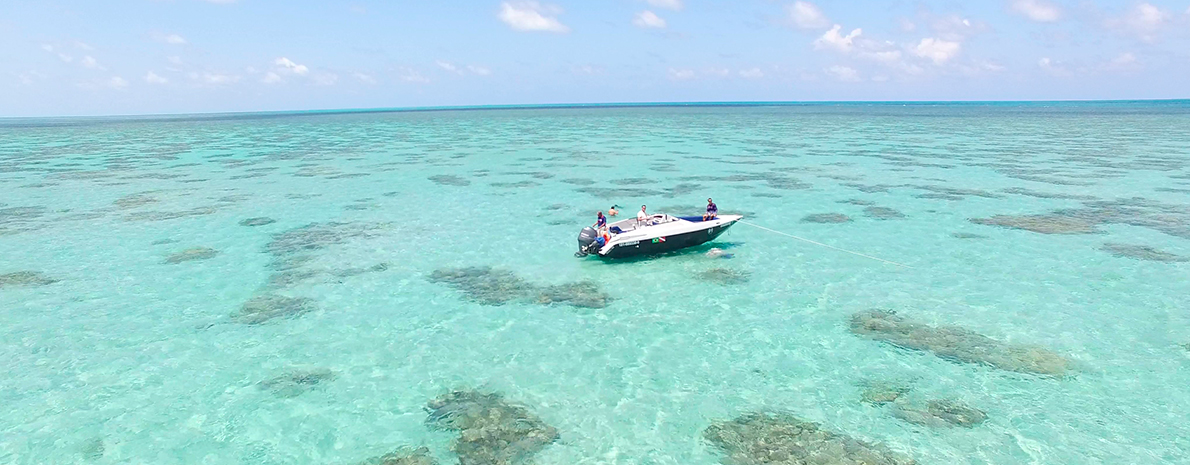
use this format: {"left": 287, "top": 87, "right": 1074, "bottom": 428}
{"left": 0, "top": 102, "right": 1190, "bottom": 464}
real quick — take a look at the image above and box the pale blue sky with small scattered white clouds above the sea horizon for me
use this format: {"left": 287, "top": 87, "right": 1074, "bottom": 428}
{"left": 0, "top": 0, "right": 1190, "bottom": 117}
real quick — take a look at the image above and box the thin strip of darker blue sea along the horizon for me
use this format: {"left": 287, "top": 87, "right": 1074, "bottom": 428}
{"left": 0, "top": 98, "right": 1190, "bottom": 121}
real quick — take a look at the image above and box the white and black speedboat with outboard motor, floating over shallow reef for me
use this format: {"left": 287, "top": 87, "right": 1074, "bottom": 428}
{"left": 575, "top": 214, "right": 744, "bottom": 258}
